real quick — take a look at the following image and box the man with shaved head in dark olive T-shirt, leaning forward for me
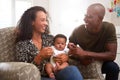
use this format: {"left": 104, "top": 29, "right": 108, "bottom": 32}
{"left": 68, "top": 3, "right": 119, "bottom": 80}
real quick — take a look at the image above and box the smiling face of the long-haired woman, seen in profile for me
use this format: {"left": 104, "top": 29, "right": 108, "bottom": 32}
{"left": 32, "top": 11, "right": 48, "bottom": 33}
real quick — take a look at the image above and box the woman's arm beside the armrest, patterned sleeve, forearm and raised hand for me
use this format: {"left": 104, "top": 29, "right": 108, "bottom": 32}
{"left": 16, "top": 42, "right": 53, "bottom": 65}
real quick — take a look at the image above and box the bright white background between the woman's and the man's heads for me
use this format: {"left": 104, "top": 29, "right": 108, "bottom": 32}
{"left": 49, "top": 0, "right": 88, "bottom": 36}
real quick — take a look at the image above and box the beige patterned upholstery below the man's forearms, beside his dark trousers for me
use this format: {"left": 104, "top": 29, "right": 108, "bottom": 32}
{"left": 69, "top": 59, "right": 104, "bottom": 80}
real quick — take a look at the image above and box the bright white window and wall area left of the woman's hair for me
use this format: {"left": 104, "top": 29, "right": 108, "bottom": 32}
{"left": 0, "top": 0, "right": 33, "bottom": 28}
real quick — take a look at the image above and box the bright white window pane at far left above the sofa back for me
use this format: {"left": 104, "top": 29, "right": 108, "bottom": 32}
{"left": 0, "top": 0, "right": 12, "bottom": 28}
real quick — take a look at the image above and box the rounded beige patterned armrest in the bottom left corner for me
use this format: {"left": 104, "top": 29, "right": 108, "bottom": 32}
{"left": 0, "top": 62, "right": 41, "bottom": 80}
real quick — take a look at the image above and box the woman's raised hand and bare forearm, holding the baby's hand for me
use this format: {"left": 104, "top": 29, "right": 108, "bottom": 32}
{"left": 34, "top": 47, "right": 53, "bottom": 65}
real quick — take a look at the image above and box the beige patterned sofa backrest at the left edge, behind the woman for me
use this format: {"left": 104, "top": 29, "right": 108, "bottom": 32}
{"left": 0, "top": 27, "right": 16, "bottom": 62}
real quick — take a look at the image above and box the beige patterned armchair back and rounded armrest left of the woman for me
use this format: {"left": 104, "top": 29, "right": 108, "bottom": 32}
{"left": 0, "top": 27, "right": 40, "bottom": 80}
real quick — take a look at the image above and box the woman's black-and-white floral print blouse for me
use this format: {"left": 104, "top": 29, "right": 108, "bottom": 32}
{"left": 16, "top": 34, "right": 53, "bottom": 76}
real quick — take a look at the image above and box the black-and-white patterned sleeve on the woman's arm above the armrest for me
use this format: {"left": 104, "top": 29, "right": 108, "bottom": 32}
{"left": 15, "top": 41, "right": 41, "bottom": 63}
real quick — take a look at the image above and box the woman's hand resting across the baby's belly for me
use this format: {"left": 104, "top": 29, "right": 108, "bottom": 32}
{"left": 55, "top": 53, "right": 68, "bottom": 64}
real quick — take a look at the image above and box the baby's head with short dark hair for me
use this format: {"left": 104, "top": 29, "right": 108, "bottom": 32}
{"left": 53, "top": 34, "right": 67, "bottom": 51}
